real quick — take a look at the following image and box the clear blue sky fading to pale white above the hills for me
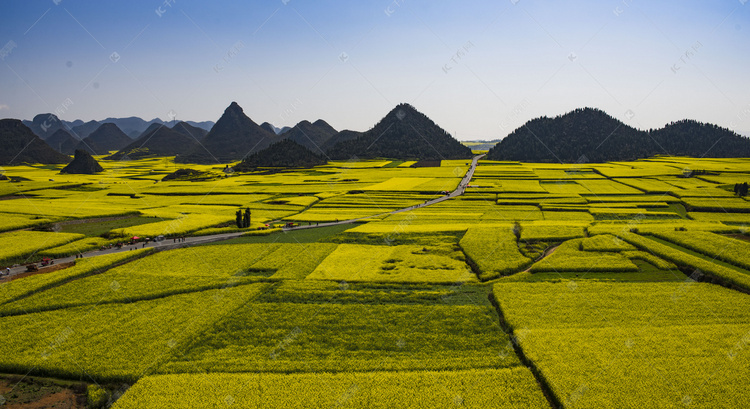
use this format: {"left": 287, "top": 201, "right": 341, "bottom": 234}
{"left": 0, "top": 0, "right": 750, "bottom": 139}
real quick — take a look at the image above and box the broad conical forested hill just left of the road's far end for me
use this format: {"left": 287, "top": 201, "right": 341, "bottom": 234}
{"left": 326, "top": 104, "right": 471, "bottom": 160}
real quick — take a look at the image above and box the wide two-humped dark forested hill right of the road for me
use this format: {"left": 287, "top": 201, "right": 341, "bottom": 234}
{"left": 487, "top": 108, "right": 750, "bottom": 163}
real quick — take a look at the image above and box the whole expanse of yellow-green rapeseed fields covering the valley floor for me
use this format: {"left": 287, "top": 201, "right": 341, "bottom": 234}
{"left": 0, "top": 157, "right": 750, "bottom": 409}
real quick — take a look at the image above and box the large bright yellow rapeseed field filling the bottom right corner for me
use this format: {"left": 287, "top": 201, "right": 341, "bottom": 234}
{"left": 494, "top": 281, "right": 750, "bottom": 408}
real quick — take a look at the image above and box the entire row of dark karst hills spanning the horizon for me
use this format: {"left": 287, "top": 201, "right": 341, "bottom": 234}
{"left": 0, "top": 102, "right": 750, "bottom": 166}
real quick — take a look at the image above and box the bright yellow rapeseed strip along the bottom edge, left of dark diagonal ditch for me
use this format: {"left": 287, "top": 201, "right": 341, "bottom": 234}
{"left": 116, "top": 368, "right": 547, "bottom": 409}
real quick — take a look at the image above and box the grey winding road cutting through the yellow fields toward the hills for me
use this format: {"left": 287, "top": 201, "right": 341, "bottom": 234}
{"left": 0, "top": 155, "right": 485, "bottom": 283}
